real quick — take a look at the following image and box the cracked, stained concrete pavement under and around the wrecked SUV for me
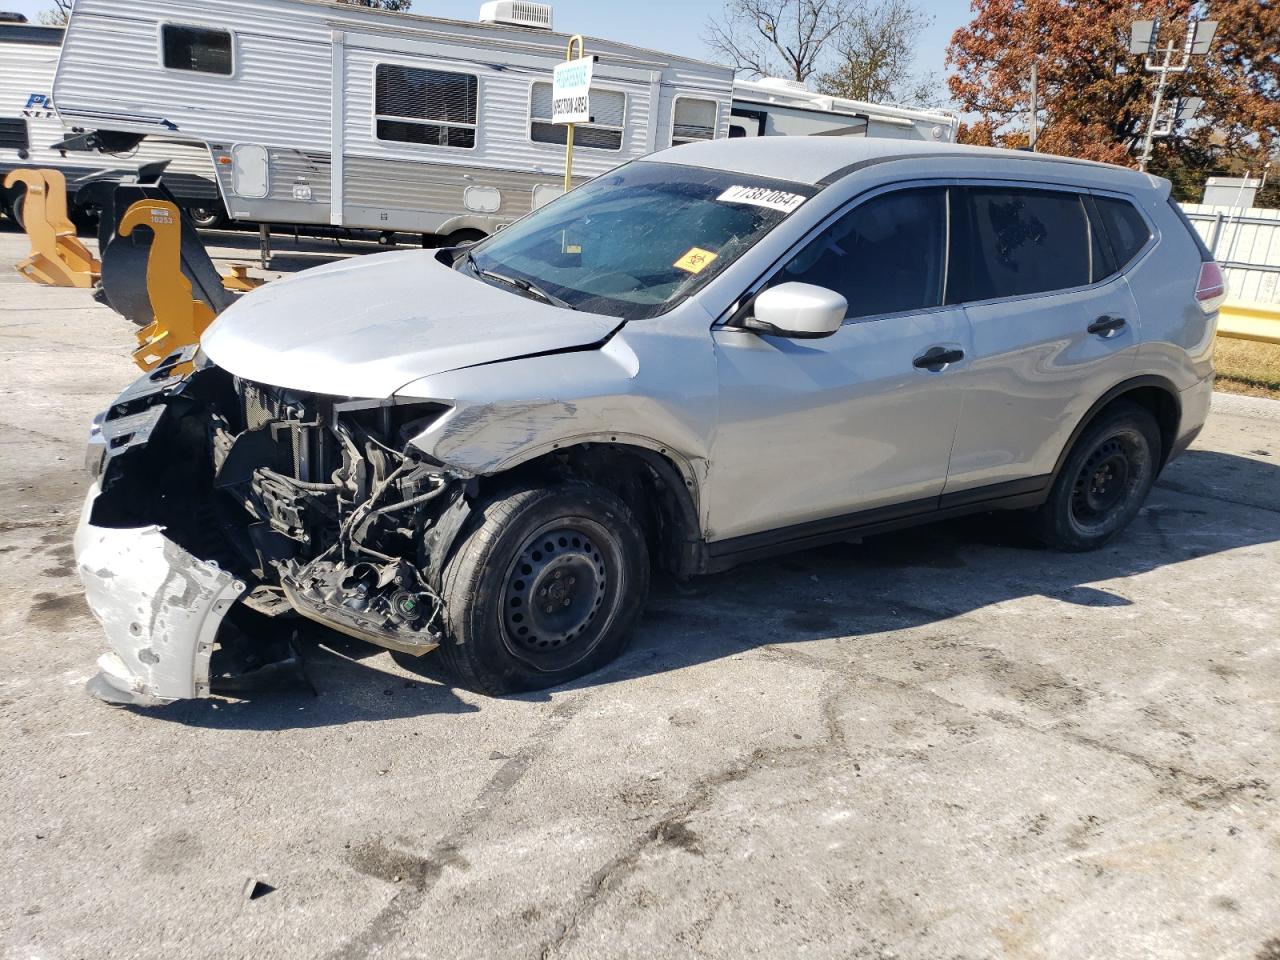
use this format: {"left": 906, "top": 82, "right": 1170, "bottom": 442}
{"left": 0, "top": 230, "right": 1280, "bottom": 960}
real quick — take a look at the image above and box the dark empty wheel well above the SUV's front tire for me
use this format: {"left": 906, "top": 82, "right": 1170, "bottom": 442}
{"left": 484, "top": 443, "right": 700, "bottom": 576}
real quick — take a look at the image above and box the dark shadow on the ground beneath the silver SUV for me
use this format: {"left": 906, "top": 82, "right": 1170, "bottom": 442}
{"left": 154, "top": 451, "right": 1280, "bottom": 730}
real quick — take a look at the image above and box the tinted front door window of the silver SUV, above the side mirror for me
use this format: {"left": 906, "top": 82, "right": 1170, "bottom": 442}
{"left": 772, "top": 188, "right": 947, "bottom": 317}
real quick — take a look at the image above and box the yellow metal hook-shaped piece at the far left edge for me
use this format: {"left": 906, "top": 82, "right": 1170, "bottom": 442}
{"left": 4, "top": 169, "right": 102, "bottom": 289}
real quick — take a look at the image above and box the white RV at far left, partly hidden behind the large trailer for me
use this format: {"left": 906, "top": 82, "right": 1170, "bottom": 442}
{"left": 0, "top": 19, "right": 221, "bottom": 225}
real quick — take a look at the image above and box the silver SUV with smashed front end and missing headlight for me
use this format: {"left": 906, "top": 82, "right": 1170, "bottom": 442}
{"left": 76, "top": 137, "right": 1224, "bottom": 704}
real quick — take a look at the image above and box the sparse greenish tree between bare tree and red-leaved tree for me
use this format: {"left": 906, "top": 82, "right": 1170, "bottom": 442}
{"left": 818, "top": 0, "right": 941, "bottom": 104}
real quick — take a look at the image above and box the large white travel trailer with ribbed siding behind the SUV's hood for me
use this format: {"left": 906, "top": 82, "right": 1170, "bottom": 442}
{"left": 54, "top": 0, "right": 733, "bottom": 241}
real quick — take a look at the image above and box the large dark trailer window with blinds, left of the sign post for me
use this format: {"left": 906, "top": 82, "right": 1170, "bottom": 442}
{"left": 374, "top": 64, "right": 480, "bottom": 150}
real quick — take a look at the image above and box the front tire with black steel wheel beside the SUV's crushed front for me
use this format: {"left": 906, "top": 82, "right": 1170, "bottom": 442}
{"left": 434, "top": 480, "right": 649, "bottom": 695}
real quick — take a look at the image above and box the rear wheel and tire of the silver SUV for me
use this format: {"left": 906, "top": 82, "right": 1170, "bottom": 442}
{"left": 1036, "top": 403, "right": 1161, "bottom": 553}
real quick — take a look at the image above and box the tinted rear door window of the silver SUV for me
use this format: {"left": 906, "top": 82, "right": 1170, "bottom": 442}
{"left": 950, "top": 187, "right": 1093, "bottom": 302}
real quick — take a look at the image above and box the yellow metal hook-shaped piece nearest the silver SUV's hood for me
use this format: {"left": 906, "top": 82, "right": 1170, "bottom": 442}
{"left": 119, "top": 200, "right": 215, "bottom": 374}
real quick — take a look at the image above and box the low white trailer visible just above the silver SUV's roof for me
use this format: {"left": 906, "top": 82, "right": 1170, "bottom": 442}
{"left": 728, "top": 77, "right": 960, "bottom": 143}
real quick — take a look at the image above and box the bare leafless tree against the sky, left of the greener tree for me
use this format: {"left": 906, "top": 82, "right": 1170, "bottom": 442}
{"left": 703, "top": 0, "right": 849, "bottom": 82}
